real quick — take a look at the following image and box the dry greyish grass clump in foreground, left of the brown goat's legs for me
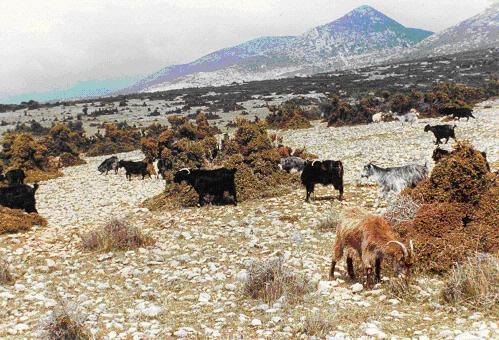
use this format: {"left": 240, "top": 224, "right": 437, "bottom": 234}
{"left": 244, "top": 258, "right": 311, "bottom": 304}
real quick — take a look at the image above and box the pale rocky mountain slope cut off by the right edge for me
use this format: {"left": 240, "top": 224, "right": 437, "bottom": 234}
{"left": 405, "top": 3, "right": 499, "bottom": 58}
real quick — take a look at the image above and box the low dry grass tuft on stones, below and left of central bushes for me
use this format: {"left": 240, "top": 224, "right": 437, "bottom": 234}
{"left": 81, "top": 219, "right": 155, "bottom": 251}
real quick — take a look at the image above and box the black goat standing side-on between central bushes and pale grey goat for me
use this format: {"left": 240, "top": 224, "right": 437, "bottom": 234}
{"left": 301, "top": 160, "right": 343, "bottom": 202}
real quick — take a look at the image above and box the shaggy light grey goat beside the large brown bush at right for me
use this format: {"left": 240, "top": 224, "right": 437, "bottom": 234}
{"left": 361, "top": 163, "right": 428, "bottom": 196}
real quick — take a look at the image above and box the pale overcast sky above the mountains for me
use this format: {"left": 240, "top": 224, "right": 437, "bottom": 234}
{"left": 0, "top": 0, "right": 492, "bottom": 97}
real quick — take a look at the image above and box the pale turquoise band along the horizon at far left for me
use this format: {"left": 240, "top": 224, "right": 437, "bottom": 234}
{"left": 0, "top": 76, "right": 142, "bottom": 104}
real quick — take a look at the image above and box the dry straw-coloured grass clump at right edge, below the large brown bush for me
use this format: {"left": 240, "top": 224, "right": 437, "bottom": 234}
{"left": 442, "top": 254, "right": 499, "bottom": 308}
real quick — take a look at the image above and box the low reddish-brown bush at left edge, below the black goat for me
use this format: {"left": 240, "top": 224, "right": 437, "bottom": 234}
{"left": 0, "top": 207, "right": 47, "bottom": 235}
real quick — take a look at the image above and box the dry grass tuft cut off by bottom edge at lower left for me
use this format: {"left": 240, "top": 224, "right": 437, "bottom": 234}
{"left": 40, "top": 301, "right": 92, "bottom": 340}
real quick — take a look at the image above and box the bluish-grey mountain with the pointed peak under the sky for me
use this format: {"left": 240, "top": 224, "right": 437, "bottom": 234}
{"left": 126, "top": 6, "right": 432, "bottom": 93}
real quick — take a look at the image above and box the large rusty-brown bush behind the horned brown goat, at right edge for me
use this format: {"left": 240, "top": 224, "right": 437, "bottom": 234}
{"left": 395, "top": 142, "right": 499, "bottom": 274}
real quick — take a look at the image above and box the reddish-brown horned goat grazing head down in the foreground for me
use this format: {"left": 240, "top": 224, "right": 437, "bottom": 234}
{"left": 329, "top": 209, "right": 414, "bottom": 289}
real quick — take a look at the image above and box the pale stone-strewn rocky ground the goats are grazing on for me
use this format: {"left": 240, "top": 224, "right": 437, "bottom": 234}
{"left": 0, "top": 102, "right": 499, "bottom": 339}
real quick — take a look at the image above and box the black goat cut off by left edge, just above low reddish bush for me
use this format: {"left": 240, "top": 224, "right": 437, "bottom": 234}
{"left": 0, "top": 183, "right": 38, "bottom": 213}
